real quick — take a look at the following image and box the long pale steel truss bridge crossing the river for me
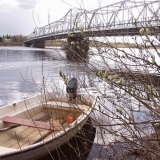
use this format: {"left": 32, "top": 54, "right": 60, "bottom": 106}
{"left": 24, "top": 0, "right": 160, "bottom": 48}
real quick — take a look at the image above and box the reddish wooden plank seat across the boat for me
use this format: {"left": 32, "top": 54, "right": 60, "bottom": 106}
{"left": 1, "top": 116, "right": 64, "bottom": 131}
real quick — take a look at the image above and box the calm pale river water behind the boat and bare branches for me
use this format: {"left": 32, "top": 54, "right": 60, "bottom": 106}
{"left": 0, "top": 47, "right": 158, "bottom": 160}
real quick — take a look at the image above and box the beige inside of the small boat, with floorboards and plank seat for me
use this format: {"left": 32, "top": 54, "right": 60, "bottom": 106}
{"left": 0, "top": 97, "right": 90, "bottom": 149}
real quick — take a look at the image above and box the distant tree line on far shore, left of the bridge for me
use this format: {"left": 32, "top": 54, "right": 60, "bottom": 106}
{"left": 0, "top": 34, "right": 27, "bottom": 43}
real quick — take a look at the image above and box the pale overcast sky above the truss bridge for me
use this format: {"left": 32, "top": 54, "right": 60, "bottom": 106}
{"left": 0, "top": 0, "right": 121, "bottom": 35}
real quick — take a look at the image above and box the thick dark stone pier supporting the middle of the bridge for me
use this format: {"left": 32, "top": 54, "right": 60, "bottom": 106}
{"left": 66, "top": 34, "right": 89, "bottom": 59}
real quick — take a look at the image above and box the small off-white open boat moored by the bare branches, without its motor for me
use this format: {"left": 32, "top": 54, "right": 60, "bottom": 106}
{"left": 0, "top": 92, "right": 96, "bottom": 160}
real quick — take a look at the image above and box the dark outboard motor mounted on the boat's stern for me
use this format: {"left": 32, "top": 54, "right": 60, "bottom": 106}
{"left": 66, "top": 78, "right": 78, "bottom": 100}
